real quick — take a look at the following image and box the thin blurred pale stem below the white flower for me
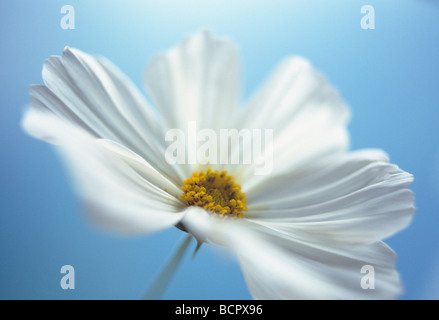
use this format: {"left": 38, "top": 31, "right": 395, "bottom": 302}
{"left": 144, "top": 234, "right": 192, "bottom": 300}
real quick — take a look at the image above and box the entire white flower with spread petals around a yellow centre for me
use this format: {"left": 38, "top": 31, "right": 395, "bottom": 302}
{"left": 23, "top": 32, "right": 415, "bottom": 299}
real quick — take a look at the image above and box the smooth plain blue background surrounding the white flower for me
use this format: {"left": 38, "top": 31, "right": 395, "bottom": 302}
{"left": 0, "top": 0, "right": 439, "bottom": 299}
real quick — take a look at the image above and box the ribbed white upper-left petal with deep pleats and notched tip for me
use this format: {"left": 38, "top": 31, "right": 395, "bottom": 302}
{"left": 23, "top": 47, "right": 181, "bottom": 182}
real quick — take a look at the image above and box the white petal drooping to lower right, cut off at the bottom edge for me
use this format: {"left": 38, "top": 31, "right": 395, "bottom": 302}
{"left": 181, "top": 207, "right": 401, "bottom": 299}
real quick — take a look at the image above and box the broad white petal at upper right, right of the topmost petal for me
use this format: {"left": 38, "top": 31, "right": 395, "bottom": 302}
{"left": 240, "top": 57, "right": 350, "bottom": 184}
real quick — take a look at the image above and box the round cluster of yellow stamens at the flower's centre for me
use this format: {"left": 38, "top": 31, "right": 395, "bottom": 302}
{"left": 181, "top": 169, "right": 248, "bottom": 219}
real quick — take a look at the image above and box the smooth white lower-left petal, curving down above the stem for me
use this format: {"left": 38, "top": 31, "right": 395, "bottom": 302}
{"left": 25, "top": 109, "right": 184, "bottom": 233}
